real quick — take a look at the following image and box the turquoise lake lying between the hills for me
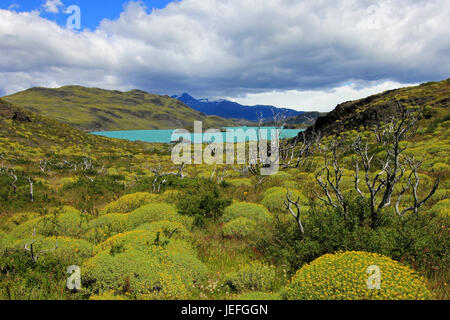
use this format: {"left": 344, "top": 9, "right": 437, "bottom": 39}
{"left": 92, "top": 127, "right": 303, "bottom": 143}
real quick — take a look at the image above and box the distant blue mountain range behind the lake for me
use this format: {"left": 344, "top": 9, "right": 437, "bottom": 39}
{"left": 172, "top": 93, "right": 304, "bottom": 121}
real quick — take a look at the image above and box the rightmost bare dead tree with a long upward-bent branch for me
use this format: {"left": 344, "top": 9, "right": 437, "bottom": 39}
{"left": 395, "top": 157, "right": 440, "bottom": 217}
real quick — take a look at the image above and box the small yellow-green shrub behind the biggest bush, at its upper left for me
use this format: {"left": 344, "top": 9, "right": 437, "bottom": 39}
{"left": 85, "top": 213, "right": 128, "bottom": 242}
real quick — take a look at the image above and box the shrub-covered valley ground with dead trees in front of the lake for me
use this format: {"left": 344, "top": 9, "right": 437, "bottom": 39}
{"left": 0, "top": 82, "right": 450, "bottom": 300}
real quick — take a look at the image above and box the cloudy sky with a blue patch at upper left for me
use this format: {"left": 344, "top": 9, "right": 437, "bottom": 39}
{"left": 0, "top": 0, "right": 450, "bottom": 111}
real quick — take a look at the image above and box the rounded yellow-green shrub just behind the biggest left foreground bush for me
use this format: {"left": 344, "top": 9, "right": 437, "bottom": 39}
{"left": 128, "top": 203, "right": 192, "bottom": 229}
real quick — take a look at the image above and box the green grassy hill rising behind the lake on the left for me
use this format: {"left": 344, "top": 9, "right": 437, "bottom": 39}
{"left": 4, "top": 86, "right": 246, "bottom": 131}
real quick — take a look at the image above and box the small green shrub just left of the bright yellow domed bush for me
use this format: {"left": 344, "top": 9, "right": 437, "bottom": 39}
{"left": 225, "top": 261, "right": 276, "bottom": 292}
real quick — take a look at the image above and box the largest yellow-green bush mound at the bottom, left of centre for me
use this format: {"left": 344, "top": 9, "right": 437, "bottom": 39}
{"left": 83, "top": 230, "right": 207, "bottom": 299}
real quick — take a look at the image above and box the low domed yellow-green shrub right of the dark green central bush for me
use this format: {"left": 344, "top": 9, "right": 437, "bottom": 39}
{"left": 222, "top": 202, "right": 272, "bottom": 223}
